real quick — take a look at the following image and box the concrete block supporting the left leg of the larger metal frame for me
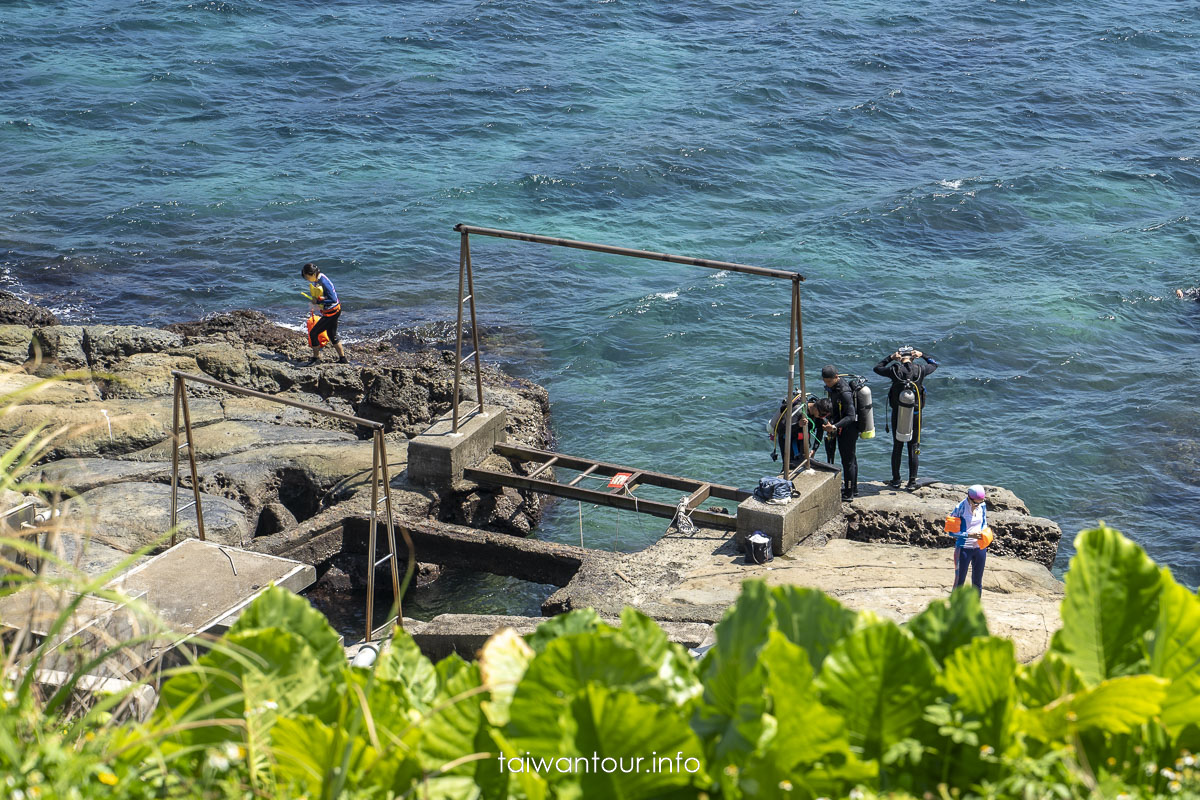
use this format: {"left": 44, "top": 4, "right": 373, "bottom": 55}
{"left": 408, "top": 405, "right": 508, "bottom": 489}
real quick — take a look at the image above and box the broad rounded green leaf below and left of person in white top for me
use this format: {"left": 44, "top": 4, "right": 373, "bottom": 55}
{"left": 817, "top": 621, "right": 937, "bottom": 758}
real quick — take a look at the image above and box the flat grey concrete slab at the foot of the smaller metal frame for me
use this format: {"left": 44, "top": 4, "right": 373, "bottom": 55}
{"left": 109, "top": 539, "right": 317, "bottom": 634}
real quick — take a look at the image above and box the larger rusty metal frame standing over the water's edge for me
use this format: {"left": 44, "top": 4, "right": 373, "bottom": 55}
{"left": 452, "top": 223, "right": 811, "bottom": 474}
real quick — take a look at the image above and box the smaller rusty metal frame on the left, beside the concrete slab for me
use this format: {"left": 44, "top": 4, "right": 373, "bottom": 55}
{"left": 170, "top": 369, "right": 416, "bottom": 642}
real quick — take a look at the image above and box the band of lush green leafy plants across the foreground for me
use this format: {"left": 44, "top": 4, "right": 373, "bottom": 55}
{"left": 0, "top": 528, "right": 1200, "bottom": 799}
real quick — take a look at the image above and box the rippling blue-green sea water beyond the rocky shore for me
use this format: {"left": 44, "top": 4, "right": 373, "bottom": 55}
{"left": 0, "top": 0, "right": 1200, "bottom": 610}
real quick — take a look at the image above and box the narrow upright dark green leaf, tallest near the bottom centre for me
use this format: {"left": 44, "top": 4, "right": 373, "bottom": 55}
{"left": 695, "top": 581, "right": 774, "bottom": 766}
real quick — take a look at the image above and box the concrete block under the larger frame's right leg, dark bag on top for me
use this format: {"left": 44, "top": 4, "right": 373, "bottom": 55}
{"left": 734, "top": 469, "right": 841, "bottom": 555}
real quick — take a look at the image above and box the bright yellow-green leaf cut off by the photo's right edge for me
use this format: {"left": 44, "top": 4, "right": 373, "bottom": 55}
{"left": 1150, "top": 572, "right": 1200, "bottom": 736}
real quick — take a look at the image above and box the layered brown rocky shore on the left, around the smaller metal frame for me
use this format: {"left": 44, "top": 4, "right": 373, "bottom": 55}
{"left": 0, "top": 295, "right": 550, "bottom": 552}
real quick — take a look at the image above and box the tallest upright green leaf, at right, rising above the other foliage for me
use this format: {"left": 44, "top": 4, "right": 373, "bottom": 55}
{"left": 1050, "top": 525, "right": 1163, "bottom": 684}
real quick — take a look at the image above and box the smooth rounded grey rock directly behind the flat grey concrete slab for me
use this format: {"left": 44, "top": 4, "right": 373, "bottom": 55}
{"left": 64, "top": 482, "right": 251, "bottom": 553}
